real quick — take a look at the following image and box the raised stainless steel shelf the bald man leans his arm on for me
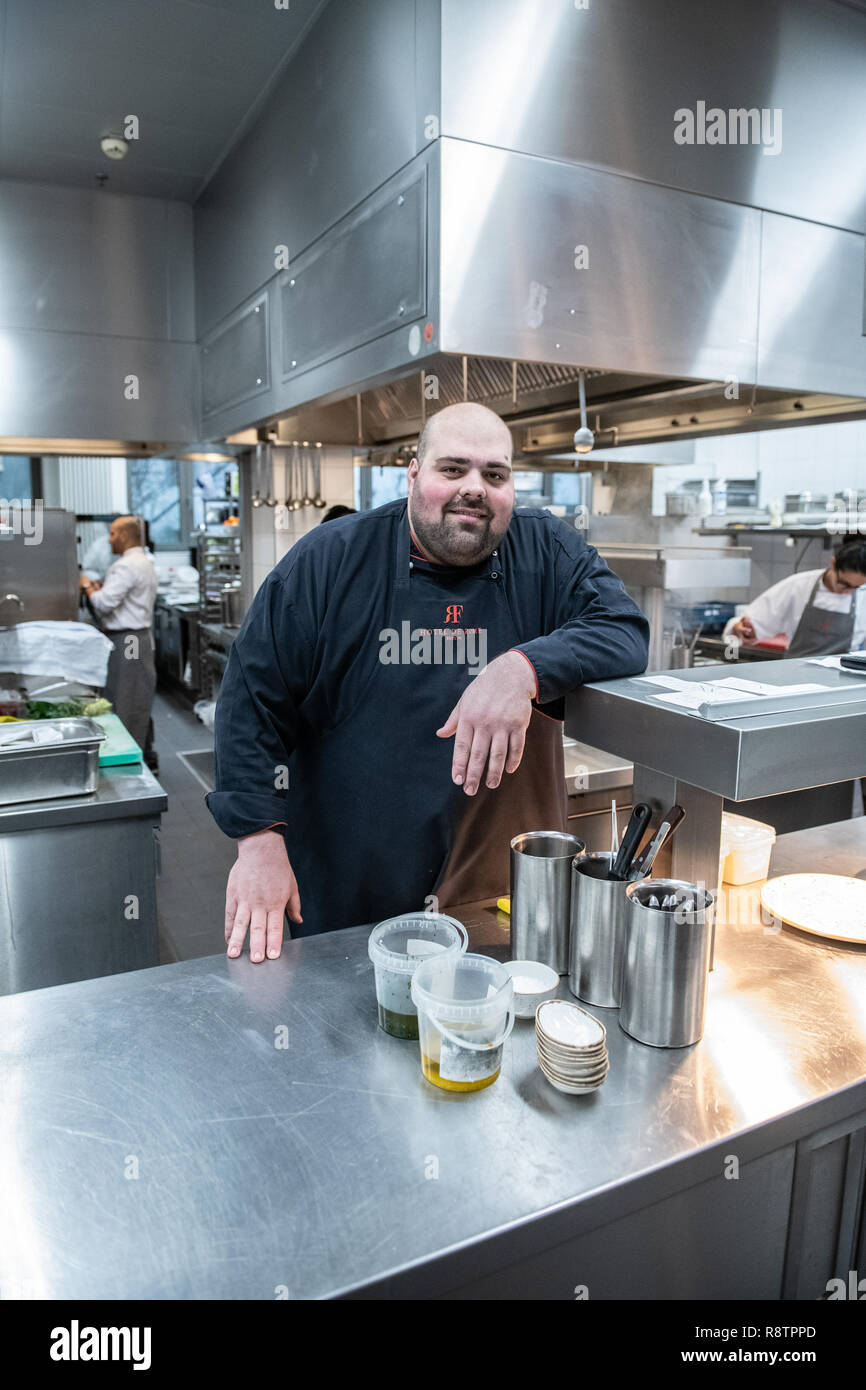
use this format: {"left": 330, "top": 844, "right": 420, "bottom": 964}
{"left": 566, "top": 659, "right": 866, "bottom": 888}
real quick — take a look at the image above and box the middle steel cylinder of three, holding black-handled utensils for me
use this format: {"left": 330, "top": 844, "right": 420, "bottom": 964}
{"left": 569, "top": 852, "right": 628, "bottom": 1009}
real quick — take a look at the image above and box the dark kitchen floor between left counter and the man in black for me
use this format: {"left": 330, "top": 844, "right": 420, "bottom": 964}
{"left": 153, "top": 691, "right": 235, "bottom": 965}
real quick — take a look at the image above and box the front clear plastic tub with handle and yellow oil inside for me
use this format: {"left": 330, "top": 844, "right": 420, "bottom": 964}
{"left": 411, "top": 951, "right": 514, "bottom": 1091}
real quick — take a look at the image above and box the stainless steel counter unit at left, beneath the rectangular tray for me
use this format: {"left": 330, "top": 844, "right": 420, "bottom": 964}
{"left": 0, "top": 766, "right": 168, "bottom": 994}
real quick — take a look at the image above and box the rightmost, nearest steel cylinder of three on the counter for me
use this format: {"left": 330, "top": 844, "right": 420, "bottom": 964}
{"left": 620, "top": 878, "right": 716, "bottom": 1047}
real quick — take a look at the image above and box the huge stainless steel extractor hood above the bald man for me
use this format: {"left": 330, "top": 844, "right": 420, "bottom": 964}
{"left": 194, "top": 0, "right": 866, "bottom": 453}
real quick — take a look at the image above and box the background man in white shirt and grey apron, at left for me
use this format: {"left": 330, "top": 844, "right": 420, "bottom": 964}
{"left": 81, "top": 517, "right": 157, "bottom": 770}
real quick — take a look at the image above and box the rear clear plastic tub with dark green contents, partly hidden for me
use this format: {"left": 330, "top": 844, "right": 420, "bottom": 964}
{"left": 367, "top": 912, "right": 468, "bottom": 1038}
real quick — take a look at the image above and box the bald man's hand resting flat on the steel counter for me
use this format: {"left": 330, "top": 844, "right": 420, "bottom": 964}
{"left": 225, "top": 830, "right": 303, "bottom": 960}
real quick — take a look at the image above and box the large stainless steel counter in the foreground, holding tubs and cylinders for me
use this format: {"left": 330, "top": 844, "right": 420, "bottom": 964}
{"left": 0, "top": 824, "right": 866, "bottom": 1300}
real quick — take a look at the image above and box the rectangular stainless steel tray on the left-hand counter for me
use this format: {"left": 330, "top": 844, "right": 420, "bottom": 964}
{"left": 0, "top": 719, "right": 106, "bottom": 806}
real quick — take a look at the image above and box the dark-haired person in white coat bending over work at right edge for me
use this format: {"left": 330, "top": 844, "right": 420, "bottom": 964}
{"left": 724, "top": 535, "right": 866, "bottom": 657}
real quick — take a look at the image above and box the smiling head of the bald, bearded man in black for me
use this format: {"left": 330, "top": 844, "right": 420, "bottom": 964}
{"left": 409, "top": 403, "right": 514, "bottom": 566}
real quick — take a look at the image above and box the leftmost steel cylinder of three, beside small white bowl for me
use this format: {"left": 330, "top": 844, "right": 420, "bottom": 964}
{"left": 512, "top": 830, "right": 587, "bottom": 974}
